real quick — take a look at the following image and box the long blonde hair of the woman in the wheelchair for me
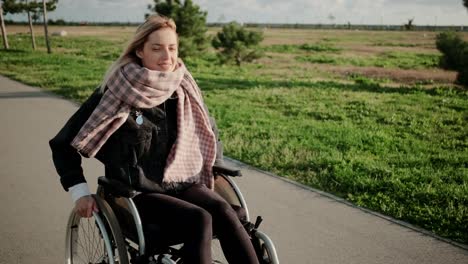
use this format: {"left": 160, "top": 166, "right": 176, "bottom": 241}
{"left": 101, "top": 14, "right": 177, "bottom": 92}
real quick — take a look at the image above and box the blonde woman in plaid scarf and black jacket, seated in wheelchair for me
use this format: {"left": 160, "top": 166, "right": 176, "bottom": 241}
{"left": 50, "top": 15, "right": 258, "bottom": 264}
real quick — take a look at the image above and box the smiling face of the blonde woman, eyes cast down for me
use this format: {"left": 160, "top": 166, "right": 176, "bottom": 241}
{"left": 137, "top": 28, "right": 178, "bottom": 71}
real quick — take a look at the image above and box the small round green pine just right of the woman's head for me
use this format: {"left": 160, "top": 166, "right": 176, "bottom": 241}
{"left": 212, "top": 22, "right": 263, "bottom": 66}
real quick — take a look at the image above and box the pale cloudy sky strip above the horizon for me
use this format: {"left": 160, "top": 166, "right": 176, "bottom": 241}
{"left": 3, "top": 0, "right": 468, "bottom": 26}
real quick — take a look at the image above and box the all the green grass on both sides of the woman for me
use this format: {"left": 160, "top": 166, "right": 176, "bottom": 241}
{"left": 0, "top": 32, "right": 468, "bottom": 243}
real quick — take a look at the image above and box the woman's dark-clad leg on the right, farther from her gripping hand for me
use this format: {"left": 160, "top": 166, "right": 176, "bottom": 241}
{"left": 177, "top": 184, "right": 258, "bottom": 264}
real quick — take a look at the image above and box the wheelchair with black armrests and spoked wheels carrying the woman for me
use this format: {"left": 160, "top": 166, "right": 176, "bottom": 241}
{"left": 65, "top": 165, "right": 279, "bottom": 264}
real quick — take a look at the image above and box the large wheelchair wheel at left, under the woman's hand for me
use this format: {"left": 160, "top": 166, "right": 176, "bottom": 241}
{"left": 65, "top": 195, "right": 129, "bottom": 264}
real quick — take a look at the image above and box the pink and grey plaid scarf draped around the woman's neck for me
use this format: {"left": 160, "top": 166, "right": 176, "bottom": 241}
{"left": 71, "top": 61, "right": 216, "bottom": 189}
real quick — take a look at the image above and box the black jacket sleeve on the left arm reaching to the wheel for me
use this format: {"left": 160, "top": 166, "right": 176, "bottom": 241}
{"left": 49, "top": 89, "right": 102, "bottom": 191}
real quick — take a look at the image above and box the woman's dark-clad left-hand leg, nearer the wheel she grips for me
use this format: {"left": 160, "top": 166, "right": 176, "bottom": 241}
{"left": 134, "top": 193, "right": 212, "bottom": 264}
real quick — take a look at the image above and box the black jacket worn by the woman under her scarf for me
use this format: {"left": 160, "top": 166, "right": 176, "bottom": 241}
{"left": 49, "top": 89, "right": 222, "bottom": 192}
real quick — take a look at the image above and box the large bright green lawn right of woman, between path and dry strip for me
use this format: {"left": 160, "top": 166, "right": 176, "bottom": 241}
{"left": 206, "top": 79, "right": 468, "bottom": 242}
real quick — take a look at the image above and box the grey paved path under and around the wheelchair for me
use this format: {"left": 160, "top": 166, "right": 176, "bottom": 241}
{"left": 0, "top": 76, "right": 468, "bottom": 264}
